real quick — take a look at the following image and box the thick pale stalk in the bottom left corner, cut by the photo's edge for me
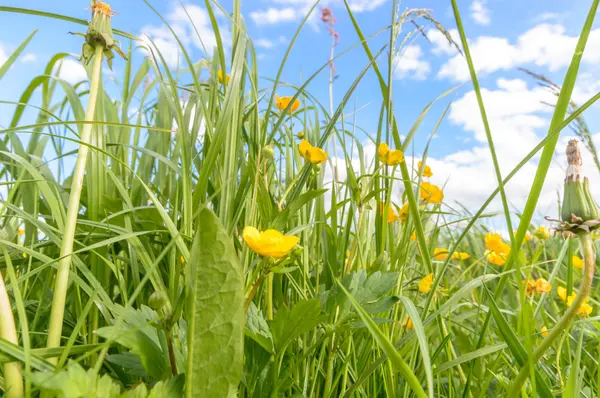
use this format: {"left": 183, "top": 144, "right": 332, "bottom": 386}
{"left": 0, "top": 273, "right": 24, "bottom": 398}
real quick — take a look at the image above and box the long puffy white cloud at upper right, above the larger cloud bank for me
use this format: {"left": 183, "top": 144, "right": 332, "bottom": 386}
{"left": 438, "top": 24, "right": 600, "bottom": 81}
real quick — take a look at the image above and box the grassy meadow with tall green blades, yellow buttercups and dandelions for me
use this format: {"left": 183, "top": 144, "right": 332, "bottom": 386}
{"left": 0, "top": 0, "right": 600, "bottom": 398}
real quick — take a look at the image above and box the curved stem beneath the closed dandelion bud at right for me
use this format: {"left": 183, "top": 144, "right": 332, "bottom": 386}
{"left": 508, "top": 233, "right": 596, "bottom": 397}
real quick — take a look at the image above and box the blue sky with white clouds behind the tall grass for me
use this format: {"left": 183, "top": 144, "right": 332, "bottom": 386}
{"left": 0, "top": 0, "right": 600, "bottom": 224}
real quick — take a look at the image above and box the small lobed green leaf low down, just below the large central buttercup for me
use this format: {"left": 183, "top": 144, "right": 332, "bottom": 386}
{"left": 271, "top": 298, "right": 324, "bottom": 354}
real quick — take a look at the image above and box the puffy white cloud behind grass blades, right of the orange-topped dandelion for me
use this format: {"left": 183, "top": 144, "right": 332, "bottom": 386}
{"left": 142, "top": 4, "right": 231, "bottom": 67}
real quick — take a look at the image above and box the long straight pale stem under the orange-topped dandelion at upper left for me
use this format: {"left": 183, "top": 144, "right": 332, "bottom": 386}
{"left": 47, "top": 46, "right": 103, "bottom": 358}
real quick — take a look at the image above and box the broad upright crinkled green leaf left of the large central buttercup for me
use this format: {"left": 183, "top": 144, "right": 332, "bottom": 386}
{"left": 186, "top": 208, "right": 245, "bottom": 398}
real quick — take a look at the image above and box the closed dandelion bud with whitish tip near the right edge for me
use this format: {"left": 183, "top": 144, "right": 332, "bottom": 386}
{"left": 561, "top": 140, "right": 600, "bottom": 222}
